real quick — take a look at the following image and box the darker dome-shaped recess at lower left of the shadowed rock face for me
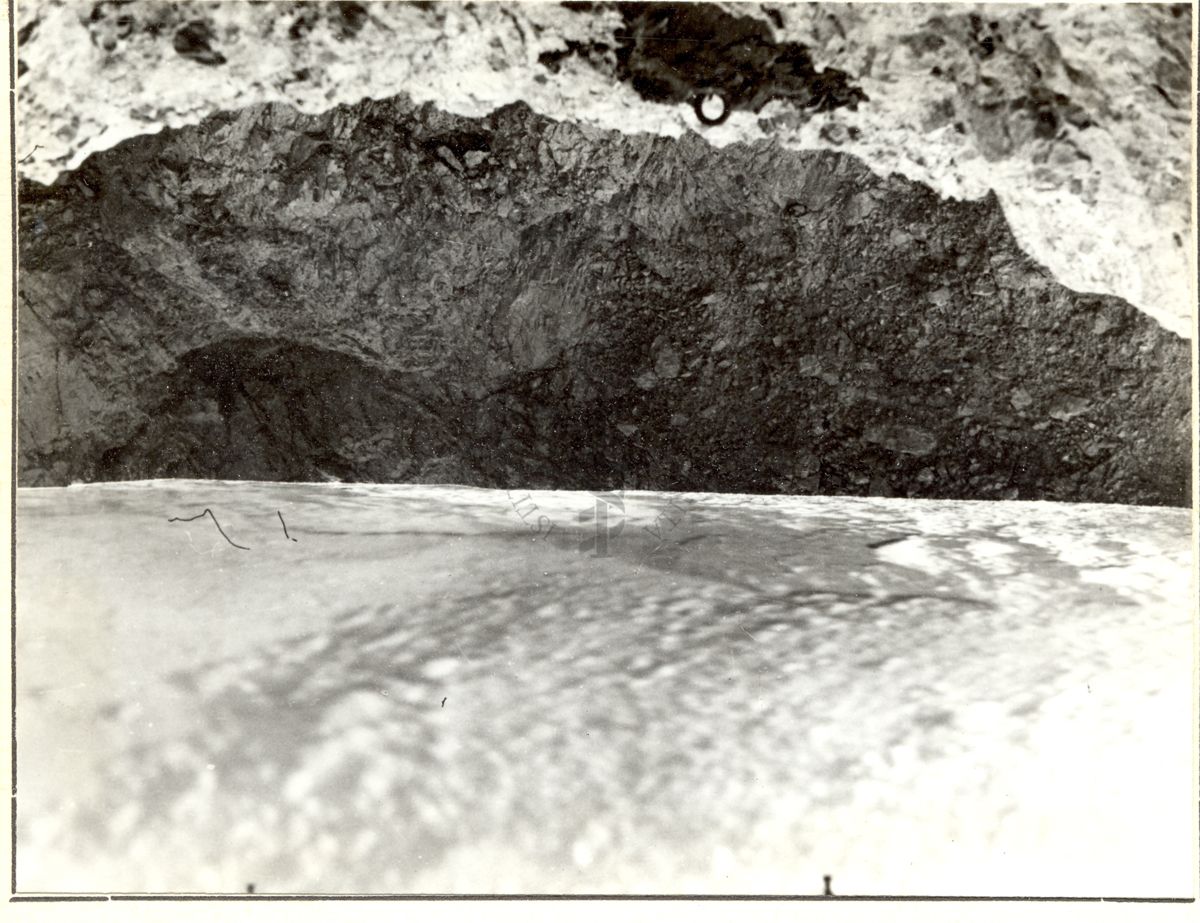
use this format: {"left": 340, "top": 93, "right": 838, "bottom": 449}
{"left": 96, "top": 337, "right": 472, "bottom": 481}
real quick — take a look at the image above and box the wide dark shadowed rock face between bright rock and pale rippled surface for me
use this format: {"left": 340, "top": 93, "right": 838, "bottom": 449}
{"left": 19, "top": 97, "right": 1190, "bottom": 504}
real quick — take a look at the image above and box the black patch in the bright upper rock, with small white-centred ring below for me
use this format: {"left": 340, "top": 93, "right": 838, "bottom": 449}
{"left": 549, "top": 2, "right": 868, "bottom": 124}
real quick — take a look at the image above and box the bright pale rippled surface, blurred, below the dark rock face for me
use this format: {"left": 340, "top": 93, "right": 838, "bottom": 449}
{"left": 17, "top": 481, "right": 1194, "bottom": 897}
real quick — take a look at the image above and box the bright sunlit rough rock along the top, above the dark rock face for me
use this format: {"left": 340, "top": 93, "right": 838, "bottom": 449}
{"left": 17, "top": 0, "right": 1194, "bottom": 336}
